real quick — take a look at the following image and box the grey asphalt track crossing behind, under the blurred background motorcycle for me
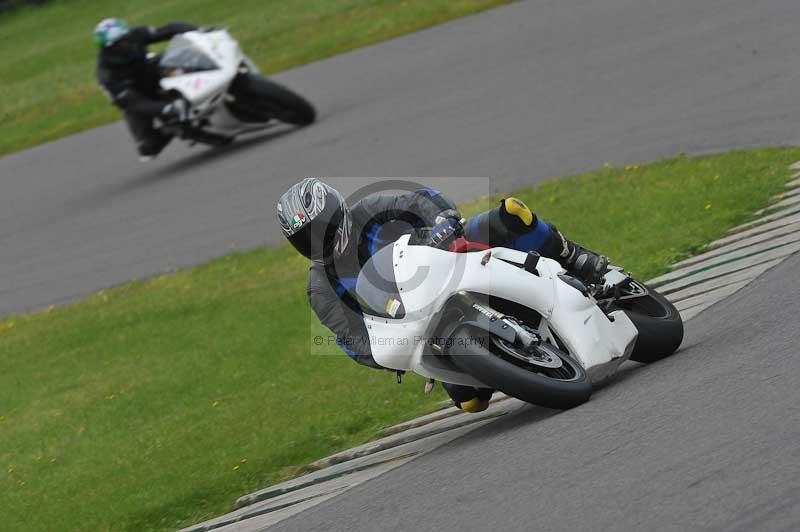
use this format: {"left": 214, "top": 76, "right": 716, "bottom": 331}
{"left": 0, "top": 0, "right": 800, "bottom": 315}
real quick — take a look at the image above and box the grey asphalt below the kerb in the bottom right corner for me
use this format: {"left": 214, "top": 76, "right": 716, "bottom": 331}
{"left": 269, "top": 247, "right": 800, "bottom": 532}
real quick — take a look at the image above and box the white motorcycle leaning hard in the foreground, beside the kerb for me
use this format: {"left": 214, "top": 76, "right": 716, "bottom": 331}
{"left": 356, "top": 231, "right": 683, "bottom": 409}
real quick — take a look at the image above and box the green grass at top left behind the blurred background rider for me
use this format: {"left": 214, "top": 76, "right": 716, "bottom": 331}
{"left": 0, "top": 0, "right": 511, "bottom": 156}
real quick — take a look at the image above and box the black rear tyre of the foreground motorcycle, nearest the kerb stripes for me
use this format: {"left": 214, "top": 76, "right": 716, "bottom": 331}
{"left": 614, "top": 281, "right": 683, "bottom": 364}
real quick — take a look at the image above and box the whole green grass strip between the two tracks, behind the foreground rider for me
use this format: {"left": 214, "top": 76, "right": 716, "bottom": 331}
{"left": 0, "top": 148, "right": 800, "bottom": 532}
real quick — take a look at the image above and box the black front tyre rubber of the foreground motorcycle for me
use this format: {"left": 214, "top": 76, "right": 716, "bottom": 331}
{"left": 448, "top": 327, "right": 592, "bottom": 410}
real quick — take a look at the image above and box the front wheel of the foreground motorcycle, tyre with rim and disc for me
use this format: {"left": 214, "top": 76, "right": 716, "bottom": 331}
{"left": 448, "top": 326, "right": 592, "bottom": 410}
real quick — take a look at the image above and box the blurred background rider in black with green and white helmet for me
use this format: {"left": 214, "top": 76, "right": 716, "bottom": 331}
{"left": 94, "top": 18, "right": 197, "bottom": 161}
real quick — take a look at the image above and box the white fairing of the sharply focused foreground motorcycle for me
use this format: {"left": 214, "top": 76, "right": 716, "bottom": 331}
{"left": 365, "top": 236, "right": 638, "bottom": 386}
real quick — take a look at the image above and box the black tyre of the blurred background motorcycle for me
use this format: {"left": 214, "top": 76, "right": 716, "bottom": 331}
{"left": 228, "top": 74, "right": 317, "bottom": 126}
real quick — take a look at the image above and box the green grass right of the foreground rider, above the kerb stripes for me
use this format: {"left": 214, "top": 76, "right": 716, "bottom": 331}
{"left": 465, "top": 148, "right": 800, "bottom": 280}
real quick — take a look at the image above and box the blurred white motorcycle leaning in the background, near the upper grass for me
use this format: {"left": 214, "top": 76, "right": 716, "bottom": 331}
{"left": 153, "top": 30, "right": 316, "bottom": 145}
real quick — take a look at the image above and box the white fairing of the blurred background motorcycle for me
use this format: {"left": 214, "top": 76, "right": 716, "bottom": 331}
{"left": 161, "top": 30, "right": 266, "bottom": 136}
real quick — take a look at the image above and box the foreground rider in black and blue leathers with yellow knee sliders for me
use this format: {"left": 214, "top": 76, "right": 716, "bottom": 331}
{"left": 277, "top": 177, "right": 608, "bottom": 412}
